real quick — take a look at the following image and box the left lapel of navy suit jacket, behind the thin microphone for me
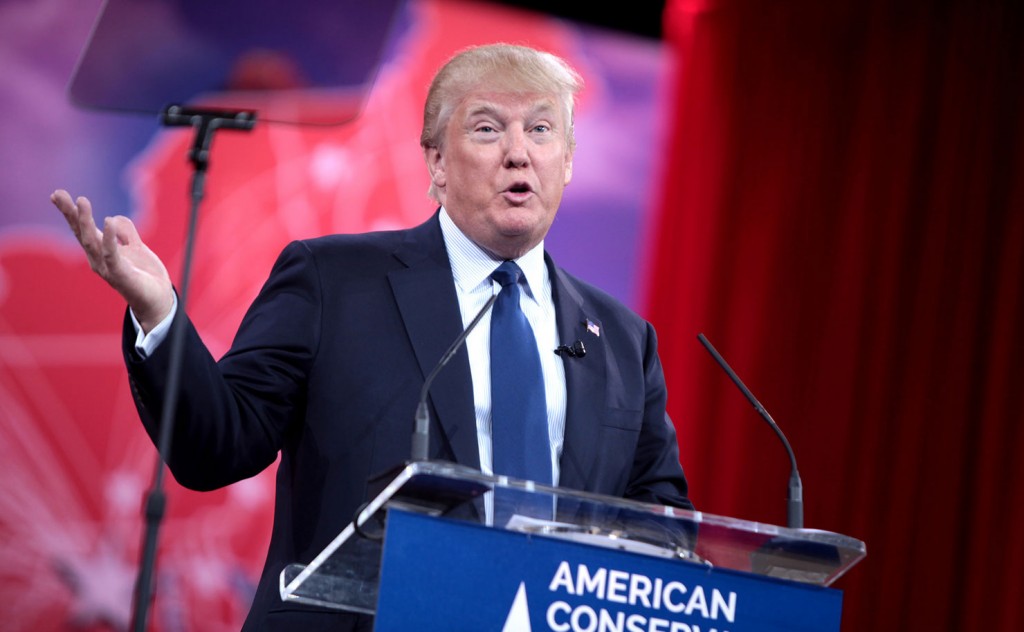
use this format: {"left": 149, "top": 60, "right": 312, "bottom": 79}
{"left": 388, "top": 215, "right": 480, "bottom": 468}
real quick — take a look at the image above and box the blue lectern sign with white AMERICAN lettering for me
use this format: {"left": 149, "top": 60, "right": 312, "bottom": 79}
{"left": 375, "top": 509, "right": 843, "bottom": 632}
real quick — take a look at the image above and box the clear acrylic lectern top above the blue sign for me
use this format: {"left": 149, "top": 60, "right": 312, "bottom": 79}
{"left": 281, "top": 461, "right": 866, "bottom": 614}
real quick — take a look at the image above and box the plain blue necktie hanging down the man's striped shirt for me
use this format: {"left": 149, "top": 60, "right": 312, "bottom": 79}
{"left": 490, "top": 261, "right": 552, "bottom": 484}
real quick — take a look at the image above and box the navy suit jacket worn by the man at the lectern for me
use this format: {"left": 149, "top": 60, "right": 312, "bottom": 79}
{"left": 124, "top": 214, "right": 691, "bottom": 630}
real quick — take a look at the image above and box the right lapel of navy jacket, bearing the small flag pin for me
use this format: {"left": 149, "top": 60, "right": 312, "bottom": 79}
{"left": 547, "top": 258, "right": 607, "bottom": 490}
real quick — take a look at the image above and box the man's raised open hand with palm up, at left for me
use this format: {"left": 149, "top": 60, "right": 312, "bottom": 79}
{"left": 50, "top": 189, "right": 174, "bottom": 332}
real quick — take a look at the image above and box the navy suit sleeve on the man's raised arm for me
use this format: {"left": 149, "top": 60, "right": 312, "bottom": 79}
{"left": 123, "top": 242, "right": 322, "bottom": 491}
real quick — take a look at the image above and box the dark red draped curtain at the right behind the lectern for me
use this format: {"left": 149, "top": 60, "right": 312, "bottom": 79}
{"left": 646, "top": 0, "right": 1024, "bottom": 630}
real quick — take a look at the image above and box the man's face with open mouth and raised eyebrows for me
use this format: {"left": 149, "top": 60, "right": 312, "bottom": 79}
{"left": 426, "top": 91, "right": 572, "bottom": 259}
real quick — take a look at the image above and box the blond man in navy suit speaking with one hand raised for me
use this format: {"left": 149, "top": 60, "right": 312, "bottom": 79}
{"left": 52, "top": 45, "right": 691, "bottom": 630}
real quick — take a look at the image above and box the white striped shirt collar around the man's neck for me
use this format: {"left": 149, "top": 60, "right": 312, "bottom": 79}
{"left": 438, "top": 206, "right": 548, "bottom": 300}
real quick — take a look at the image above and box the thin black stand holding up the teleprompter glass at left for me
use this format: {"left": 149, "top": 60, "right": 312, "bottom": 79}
{"left": 132, "top": 106, "right": 256, "bottom": 632}
